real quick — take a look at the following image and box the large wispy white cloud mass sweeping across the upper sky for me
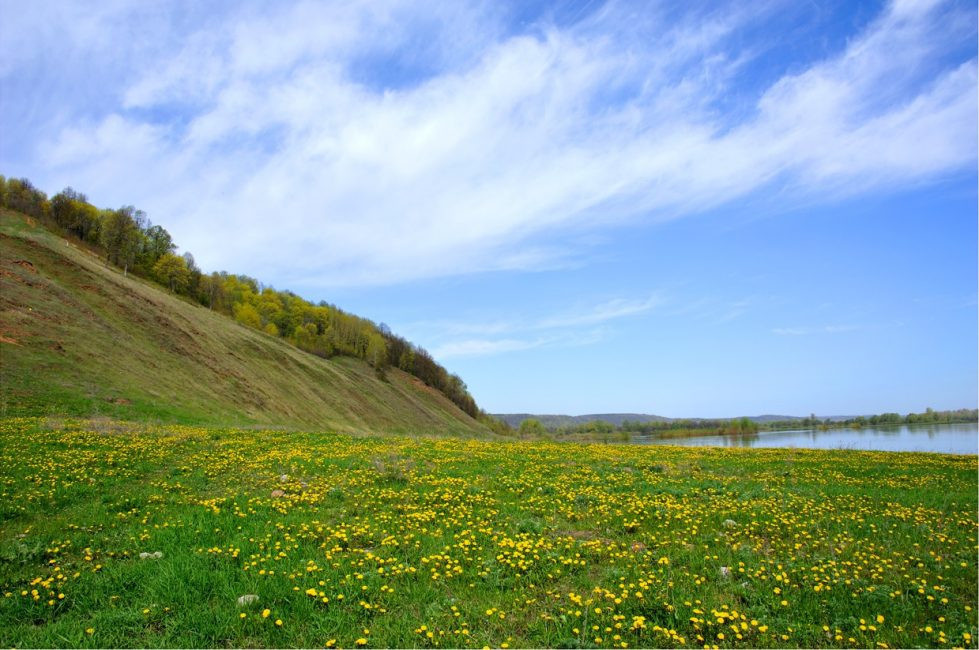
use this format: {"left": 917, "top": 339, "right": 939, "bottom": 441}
{"left": 4, "top": 1, "right": 977, "bottom": 284}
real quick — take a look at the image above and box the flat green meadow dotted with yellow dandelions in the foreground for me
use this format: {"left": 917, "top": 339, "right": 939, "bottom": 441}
{"left": 0, "top": 418, "right": 977, "bottom": 648}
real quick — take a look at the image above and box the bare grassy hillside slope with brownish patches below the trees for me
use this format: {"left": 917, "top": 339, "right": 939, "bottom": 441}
{"left": 0, "top": 210, "right": 488, "bottom": 435}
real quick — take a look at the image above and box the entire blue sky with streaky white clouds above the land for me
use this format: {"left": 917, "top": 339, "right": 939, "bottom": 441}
{"left": 0, "top": 0, "right": 979, "bottom": 417}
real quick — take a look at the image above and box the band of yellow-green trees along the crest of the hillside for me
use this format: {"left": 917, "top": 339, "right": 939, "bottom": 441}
{"left": 0, "top": 176, "right": 480, "bottom": 418}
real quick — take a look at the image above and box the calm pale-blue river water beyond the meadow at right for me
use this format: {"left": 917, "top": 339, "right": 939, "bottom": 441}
{"left": 632, "top": 422, "right": 979, "bottom": 454}
